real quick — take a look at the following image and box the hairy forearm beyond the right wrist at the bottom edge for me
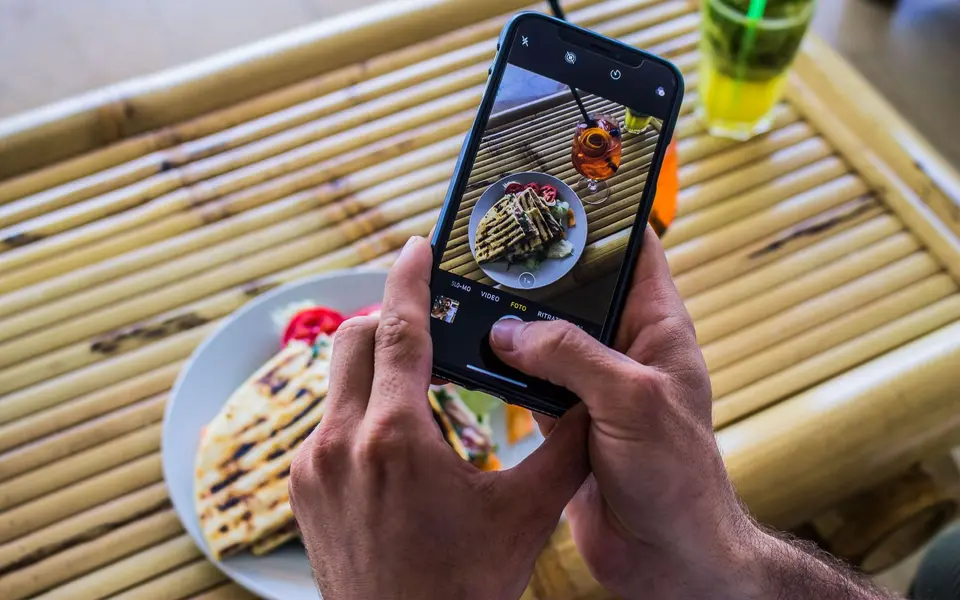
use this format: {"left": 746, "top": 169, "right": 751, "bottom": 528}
{"left": 739, "top": 531, "right": 899, "bottom": 600}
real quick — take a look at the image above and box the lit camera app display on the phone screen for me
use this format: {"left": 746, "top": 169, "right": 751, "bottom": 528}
{"left": 431, "top": 30, "right": 663, "bottom": 394}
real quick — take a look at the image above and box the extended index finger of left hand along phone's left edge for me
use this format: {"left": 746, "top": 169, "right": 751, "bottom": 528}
{"left": 367, "top": 237, "right": 433, "bottom": 426}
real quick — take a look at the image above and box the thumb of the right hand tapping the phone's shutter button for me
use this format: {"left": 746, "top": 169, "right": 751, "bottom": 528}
{"left": 490, "top": 319, "right": 634, "bottom": 404}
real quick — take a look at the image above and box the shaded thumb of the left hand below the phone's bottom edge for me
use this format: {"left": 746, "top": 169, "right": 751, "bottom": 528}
{"left": 502, "top": 404, "right": 590, "bottom": 518}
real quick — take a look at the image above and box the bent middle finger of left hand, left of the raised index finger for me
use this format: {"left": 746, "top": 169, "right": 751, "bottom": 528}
{"left": 323, "top": 316, "right": 379, "bottom": 427}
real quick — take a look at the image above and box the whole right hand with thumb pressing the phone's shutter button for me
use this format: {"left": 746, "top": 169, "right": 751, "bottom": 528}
{"left": 491, "top": 227, "right": 760, "bottom": 598}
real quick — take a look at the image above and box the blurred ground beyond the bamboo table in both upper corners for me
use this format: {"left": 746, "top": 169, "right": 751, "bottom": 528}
{"left": 0, "top": 0, "right": 960, "bottom": 165}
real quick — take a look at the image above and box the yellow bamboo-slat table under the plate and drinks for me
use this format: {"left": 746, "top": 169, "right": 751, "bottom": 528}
{"left": 0, "top": 0, "right": 960, "bottom": 599}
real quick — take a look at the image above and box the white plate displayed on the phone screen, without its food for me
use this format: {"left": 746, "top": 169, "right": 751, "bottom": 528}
{"left": 467, "top": 171, "right": 587, "bottom": 290}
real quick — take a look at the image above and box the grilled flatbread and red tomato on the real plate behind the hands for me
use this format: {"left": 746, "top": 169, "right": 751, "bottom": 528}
{"left": 194, "top": 303, "right": 499, "bottom": 559}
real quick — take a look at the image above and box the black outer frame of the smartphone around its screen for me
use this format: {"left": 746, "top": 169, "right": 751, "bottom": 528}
{"left": 431, "top": 12, "right": 684, "bottom": 416}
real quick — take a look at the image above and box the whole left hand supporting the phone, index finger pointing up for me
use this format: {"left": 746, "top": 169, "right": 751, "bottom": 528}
{"left": 290, "top": 238, "right": 589, "bottom": 600}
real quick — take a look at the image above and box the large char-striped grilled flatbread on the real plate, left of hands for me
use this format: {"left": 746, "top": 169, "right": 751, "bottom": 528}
{"left": 194, "top": 336, "right": 332, "bottom": 558}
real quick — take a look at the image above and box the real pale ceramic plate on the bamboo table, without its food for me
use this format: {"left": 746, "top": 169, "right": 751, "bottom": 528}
{"left": 162, "top": 270, "right": 541, "bottom": 600}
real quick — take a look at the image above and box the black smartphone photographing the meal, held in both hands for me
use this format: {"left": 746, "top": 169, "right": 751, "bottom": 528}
{"left": 430, "top": 13, "right": 683, "bottom": 416}
